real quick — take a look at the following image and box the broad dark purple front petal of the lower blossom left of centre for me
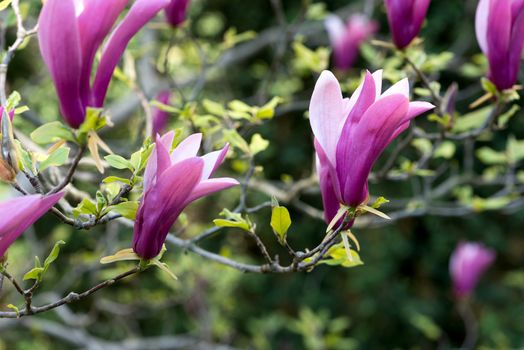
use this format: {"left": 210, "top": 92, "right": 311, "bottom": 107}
{"left": 133, "top": 157, "right": 204, "bottom": 259}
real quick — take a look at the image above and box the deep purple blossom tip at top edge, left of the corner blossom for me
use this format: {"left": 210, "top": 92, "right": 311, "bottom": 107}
{"left": 384, "top": 0, "right": 430, "bottom": 49}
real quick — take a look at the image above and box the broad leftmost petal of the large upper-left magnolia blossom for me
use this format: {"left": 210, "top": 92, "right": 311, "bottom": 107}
{"left": 38, "top": 0, "right": 85, "bottom": 128}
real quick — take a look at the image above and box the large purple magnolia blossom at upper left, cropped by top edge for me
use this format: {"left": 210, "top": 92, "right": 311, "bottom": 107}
{"left": 38, "top": 0, "right": 169, "bottom": 128}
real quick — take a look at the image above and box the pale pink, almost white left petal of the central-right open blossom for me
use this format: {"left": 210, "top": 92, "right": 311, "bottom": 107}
{"left": 309, "top": 71, "right": 350, "bottom": 164}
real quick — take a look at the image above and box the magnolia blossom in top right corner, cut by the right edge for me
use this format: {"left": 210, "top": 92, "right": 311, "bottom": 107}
{"left": 475, "top": 0, "right": 524, "bottom": 90}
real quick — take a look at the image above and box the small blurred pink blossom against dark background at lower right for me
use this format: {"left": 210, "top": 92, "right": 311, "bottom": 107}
{"left": 449, "top": 242, "right": 496, "bottom": 296}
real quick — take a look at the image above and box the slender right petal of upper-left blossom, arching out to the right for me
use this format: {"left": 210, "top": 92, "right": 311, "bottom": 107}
{"left": 91, "top": 0, "right": 169, "bottom": 107}
